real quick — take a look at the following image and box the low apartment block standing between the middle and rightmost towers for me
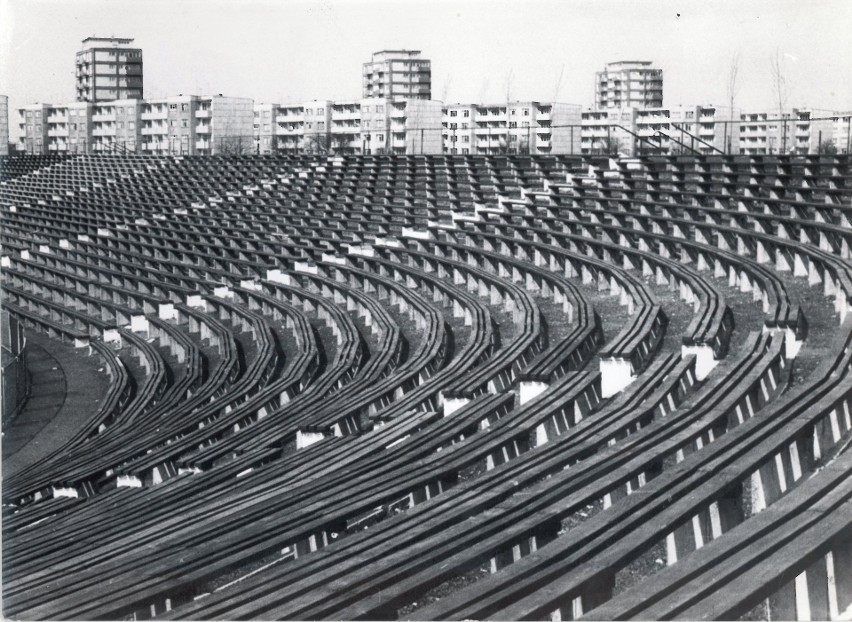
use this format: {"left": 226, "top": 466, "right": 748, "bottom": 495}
{"left": 442, "top": 101, "right": 581, "bottom": 155}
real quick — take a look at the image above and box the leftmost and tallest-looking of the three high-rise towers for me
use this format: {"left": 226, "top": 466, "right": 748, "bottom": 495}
{"left": 76, "top": 37, "right": 143, "bottom": 103}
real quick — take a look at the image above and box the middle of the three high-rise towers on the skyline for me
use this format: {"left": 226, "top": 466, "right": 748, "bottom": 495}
{"left": 363, "top": 50, "right": 432, "bottom": 100}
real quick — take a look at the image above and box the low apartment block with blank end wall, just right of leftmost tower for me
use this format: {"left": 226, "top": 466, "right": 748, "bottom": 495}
{"left": 140, "top": 95, "right": 254, "bottom": 155}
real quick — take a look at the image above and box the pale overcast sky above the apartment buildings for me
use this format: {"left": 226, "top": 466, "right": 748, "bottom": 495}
{"left": 0, "top": 0, "right": 852, "bottom": 134}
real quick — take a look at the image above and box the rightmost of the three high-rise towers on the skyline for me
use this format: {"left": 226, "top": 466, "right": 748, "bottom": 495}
{"left": 595, "top": 60, "right": 663, "bottom": 110}
